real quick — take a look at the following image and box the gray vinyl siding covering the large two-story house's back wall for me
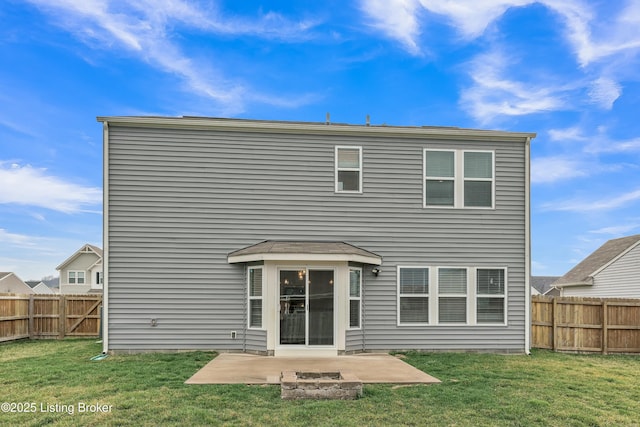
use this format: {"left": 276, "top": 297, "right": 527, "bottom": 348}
{"left": 106, "top": 125, "right": 528, "bottom": 351}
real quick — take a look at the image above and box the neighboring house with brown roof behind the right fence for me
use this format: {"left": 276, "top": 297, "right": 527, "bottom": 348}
{"left": 553, "top": 234, "right": 640, "bottom": 298}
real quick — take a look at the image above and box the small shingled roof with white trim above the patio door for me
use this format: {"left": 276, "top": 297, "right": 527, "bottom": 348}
{"left": 227, "top": 240, "right": 382, "bottom": 265}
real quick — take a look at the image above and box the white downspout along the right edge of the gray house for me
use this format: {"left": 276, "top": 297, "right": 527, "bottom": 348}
{"left": 524, "top": 137, "right": 531, "bottom": 354}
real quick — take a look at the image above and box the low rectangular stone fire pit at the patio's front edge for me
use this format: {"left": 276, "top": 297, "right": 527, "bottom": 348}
{"left": 280, "top": 371, "right": 362, "bottom": 400}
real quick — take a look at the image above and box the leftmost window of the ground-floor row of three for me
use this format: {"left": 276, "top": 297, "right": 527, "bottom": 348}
{"left": 398, "top": 267, "right": 429, "bottom": 325}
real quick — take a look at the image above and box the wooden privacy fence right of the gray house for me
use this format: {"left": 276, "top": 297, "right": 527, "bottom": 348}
{"left": 531, "top": 295, "right": 640, "bottom": 354}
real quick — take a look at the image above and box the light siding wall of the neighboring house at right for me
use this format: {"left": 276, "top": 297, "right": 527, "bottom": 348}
{"left": 563, "top": 245, "right": 640, "bottom": 298}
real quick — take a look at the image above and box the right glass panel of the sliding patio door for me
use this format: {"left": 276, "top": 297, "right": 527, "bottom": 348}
{"left": 308, "top": 270, "right": 333, "bottom": 345}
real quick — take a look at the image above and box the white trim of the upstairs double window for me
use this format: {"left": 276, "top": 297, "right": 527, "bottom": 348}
{"left": 422, "top": 148, "right": 496, "bottom": 210}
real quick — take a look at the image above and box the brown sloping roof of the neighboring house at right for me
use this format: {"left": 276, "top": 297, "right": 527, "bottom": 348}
{"left": 553, "top": 234, "right": 640, "bottom": 287}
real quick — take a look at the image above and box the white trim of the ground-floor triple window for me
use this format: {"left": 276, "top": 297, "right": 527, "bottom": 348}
{"left": 396, "top": 265, "right": 509, "bottom": 327}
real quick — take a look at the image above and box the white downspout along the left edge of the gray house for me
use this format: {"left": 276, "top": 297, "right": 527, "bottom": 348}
{"left": 101, "top": 120, "right": 109, "bottom": 353}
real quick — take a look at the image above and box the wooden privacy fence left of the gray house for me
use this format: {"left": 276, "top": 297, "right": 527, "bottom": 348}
{"left": 0, "top": 294, "right": 102, "bottom": 342}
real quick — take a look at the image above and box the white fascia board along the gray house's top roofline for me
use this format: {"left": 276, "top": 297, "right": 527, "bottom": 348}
{"left": 97, "top": 116, "right": 536, "bottom": 142}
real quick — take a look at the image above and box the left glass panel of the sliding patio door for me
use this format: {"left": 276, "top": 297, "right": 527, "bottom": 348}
{"left": 280, "top": 269, "right": 307, "bottom": 345}
